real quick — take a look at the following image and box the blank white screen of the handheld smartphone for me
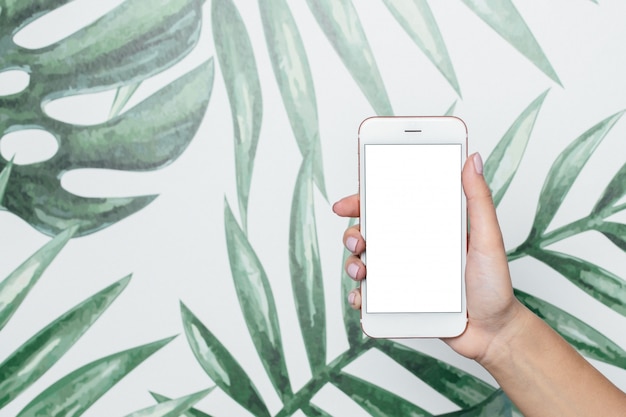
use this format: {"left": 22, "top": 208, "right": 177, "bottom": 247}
{"left": 363, "top": 144, "right": 463, "bottom": 313}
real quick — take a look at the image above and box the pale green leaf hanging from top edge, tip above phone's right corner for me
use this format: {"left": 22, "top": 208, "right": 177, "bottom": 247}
{"left": 384, "top": 0, "right": 461, "bottom": 97}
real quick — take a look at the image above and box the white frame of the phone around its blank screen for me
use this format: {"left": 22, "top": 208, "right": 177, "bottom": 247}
{"left": 358, "top": 116, "right": 468, "bottom": 338}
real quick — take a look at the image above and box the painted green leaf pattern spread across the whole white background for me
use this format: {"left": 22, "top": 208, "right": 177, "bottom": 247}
{"left": 0, "top": 0, "right": 626, "bottom": 416}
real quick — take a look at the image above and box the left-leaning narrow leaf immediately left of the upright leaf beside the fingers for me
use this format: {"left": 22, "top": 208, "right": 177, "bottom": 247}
{"left": 224, "top": 199, "right": 293, "bottom": 401}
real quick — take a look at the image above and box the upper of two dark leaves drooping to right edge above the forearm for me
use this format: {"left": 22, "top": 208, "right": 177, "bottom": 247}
{"left": 529, "top": 249, "right": 626, "bottom": 316}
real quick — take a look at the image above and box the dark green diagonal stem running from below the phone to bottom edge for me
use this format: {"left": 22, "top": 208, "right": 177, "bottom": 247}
{"left": 275, "top": 339, "right": 376, "bottom": 417}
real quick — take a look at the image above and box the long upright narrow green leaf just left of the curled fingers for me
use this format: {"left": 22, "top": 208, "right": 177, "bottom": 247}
{"left": 289, "top": 159, "right": 326, "bottom": 375}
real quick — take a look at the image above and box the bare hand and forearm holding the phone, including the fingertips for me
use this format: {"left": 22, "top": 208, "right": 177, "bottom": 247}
{"left": 333, "top": 154, "right": 626, "bottom": 417}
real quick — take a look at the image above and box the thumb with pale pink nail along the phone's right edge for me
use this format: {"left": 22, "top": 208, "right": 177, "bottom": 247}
{"left": 462, "top": 153, "right": 504, "bottom": 254}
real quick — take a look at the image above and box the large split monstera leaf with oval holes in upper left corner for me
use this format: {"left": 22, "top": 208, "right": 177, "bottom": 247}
{"left": 0, "top": 0, "right": 213, "bottom": 236}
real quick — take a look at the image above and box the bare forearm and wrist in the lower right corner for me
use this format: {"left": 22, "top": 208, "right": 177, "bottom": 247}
{"left": 479, "top": 305, "right": 626, "bottom": 417}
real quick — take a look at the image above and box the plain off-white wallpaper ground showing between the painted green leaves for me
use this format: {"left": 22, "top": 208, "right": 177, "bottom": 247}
{"left": 0, "top": 0, "right": 626, "bottom": 416}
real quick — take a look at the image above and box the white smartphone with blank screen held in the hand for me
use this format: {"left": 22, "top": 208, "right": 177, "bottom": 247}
{"left": 359, "top": 116, "right": 467, "bottom": 338}
